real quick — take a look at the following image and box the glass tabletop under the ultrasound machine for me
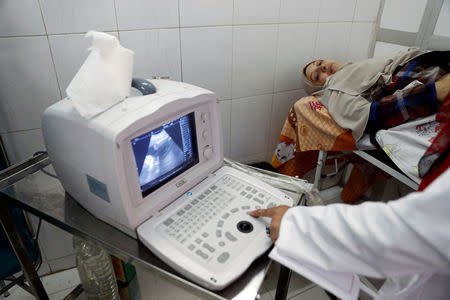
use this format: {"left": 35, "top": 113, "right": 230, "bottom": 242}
{"left": 1, "top": 158, "right": 304, "bottom": 299}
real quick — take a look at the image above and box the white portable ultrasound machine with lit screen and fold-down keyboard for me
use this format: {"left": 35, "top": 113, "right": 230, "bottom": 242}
{"left": 42, "top": 80, "right": 292, "bottom": 290}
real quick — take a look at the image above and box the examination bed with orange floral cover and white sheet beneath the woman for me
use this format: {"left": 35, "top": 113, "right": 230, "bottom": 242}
{"left": 271, "top": 96, "right": 439, "bottom": 198}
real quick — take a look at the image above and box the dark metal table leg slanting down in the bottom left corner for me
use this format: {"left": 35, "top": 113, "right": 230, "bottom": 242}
{"left": 0, "top": 197, "right": 49, "bottom": 299}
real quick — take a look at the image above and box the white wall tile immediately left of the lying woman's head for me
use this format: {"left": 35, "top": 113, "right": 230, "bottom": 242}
{"left": 275, "top": 23, "right": 317, "bottom": 92}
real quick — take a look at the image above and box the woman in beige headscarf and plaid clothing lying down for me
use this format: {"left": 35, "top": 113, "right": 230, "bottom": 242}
{"left": 303, "top": 49, "right": 450, "bottom": 141}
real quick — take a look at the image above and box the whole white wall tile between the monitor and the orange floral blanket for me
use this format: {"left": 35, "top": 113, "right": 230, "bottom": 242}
{"left": 230, "top": 94, "right": 272, "bottom": 162}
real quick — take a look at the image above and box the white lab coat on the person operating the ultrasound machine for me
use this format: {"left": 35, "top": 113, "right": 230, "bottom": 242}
{"left": 270, "top": 169, "right": 450, "bottom": 299}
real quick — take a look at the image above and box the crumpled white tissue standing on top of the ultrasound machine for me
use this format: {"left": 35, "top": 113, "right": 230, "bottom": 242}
{"left": 66, "top": 31, "right": 134, "bottom": 119}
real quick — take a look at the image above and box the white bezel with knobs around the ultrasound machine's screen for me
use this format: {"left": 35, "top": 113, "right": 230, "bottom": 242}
{"left": 115, "top": 94, "right": 223, "bottom": 216}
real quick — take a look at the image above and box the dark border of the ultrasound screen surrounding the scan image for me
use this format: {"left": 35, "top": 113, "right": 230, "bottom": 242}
{"left": 130, "top": 111, "right": 200, "bottom": 198}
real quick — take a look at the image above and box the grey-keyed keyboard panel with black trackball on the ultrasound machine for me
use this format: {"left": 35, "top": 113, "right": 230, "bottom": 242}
{"left": 157, "top": 175, "right": 278, "bottom": 268}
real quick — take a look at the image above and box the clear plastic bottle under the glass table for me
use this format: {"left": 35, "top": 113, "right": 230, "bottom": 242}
{"left": 73, "top": 236, "right": 120, "bottom": 300}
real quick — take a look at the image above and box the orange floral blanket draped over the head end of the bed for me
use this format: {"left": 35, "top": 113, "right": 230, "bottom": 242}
{"left": 271, "top": 96, "right": 388, "bottom": 203}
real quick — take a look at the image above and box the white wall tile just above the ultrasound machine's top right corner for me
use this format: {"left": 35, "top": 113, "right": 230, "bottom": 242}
{"left": 181, "top": 26, "right": 232, "bottom": 100}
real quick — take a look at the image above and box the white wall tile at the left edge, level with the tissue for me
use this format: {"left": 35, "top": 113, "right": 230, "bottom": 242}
{"left": 0, "top": 36, "right": 60, "bottom": 132}
